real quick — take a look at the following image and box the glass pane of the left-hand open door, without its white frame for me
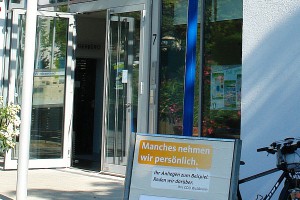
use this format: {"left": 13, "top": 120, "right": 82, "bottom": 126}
{"left": 30, "top": 16, "right": 68, "bottom": 159}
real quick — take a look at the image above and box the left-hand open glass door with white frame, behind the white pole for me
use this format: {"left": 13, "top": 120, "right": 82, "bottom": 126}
{"left": 4, "top": 10, "right": 75, "bottom": 169}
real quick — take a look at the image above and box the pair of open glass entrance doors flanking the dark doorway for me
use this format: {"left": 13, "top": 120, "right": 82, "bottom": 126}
{"left": 4, "top": 4, "right": 150, "bottom": 174}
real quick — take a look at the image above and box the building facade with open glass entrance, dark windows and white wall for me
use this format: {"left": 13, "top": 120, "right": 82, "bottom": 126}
{"left": 0, "top": 0, "right": 300, "bottom": 199}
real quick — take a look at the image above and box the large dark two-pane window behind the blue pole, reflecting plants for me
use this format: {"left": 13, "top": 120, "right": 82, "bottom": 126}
{"left": 158, "top": 0, "right": 243, "bottom": 138}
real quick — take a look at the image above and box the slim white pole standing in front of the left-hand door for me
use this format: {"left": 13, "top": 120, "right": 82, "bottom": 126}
{"left": 17, "top": 0, "right": 37, "bottom": 200}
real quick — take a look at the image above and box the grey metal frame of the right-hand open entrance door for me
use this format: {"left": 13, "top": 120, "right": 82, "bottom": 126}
{"left": 101, "top": 4, "right": 151, "bottom": 175}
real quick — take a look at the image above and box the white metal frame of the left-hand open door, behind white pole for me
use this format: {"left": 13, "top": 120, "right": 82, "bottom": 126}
{"left": 4, "top": 9, "right": 76, "bottom": 169}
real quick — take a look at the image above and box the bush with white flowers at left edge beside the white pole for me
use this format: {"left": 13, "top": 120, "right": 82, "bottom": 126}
{"left": 0, "top": 97, "right": 21, "bottom": 154}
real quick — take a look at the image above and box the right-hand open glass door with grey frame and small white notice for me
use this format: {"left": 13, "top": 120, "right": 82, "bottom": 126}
{"left": 102, "top": 6, "right": 144, "bottom": 174}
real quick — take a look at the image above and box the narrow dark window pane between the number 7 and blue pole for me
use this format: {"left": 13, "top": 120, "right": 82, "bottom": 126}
{"left": 158, "top": 0, "right": 188, "bottom": 135}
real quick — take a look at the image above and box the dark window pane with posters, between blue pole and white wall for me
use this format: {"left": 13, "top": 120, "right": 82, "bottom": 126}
{"left": 202, "top": 0, "right": 243, "bottom": 138}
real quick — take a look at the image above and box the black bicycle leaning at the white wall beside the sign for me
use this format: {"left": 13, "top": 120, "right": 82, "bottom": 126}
{"left": 237, "top": 138, "right": 300, "bottom": 200}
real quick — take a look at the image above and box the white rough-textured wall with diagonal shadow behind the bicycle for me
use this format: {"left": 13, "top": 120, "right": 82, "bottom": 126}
{"left": 240, "top": 0, "right": 300, "bottom": 199}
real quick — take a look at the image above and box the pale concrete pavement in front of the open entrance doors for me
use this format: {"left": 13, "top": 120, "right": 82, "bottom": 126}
{"left": 0, "top": 168, "right": 124, "bottom": 200}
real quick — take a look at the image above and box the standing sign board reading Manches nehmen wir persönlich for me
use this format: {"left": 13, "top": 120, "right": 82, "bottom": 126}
{"left": 124, "top": 134, "right": 241, "bottom": 200}
